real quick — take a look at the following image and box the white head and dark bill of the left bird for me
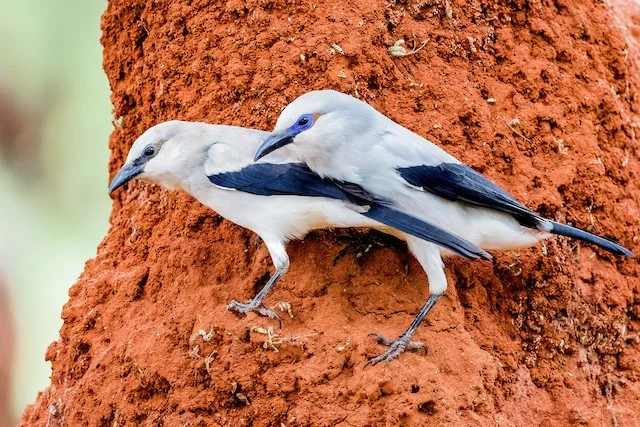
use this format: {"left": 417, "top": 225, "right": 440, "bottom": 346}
{"left": 109, "top": 120, "right": 215, "bottom": 193}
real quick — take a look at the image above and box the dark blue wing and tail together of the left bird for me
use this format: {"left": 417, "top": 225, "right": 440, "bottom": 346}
{"left": 209, "top": 163, "right": 491, "bottom": 259}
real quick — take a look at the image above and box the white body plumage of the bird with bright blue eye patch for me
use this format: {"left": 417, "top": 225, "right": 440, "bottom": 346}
{"left": 266, "top": 90, "right": 549, "bottom": 250}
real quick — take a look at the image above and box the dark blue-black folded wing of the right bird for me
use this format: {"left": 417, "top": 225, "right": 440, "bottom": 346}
{"left": 398, "top": 163, "right": 542, "bottom": 228}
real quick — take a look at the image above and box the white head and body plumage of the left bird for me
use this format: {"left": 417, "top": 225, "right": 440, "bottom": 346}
{"left": 117, "top": 121, "right": 403, "bottom": 278}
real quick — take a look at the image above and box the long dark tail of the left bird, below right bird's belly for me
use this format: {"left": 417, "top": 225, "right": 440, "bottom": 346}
{"left": 362, "top": 204, "right": 491, "bottom": 259}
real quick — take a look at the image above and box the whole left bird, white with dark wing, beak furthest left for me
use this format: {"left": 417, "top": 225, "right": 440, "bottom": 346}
{"left": 109, "top": 121, "right": 490, "bottom": 328}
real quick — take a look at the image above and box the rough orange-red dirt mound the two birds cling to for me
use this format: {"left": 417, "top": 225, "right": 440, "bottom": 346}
{"left": 21, "top": 0, "right": 640, "bottom": 427}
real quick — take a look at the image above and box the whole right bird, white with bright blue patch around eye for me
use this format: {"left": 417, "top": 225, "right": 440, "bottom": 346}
{"left": 255, "top": 90, "right": 633, "bottom": 363}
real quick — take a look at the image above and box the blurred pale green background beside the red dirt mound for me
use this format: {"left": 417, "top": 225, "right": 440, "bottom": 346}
{"left": 0, "top": 0, "right": 112, "bottom": 426}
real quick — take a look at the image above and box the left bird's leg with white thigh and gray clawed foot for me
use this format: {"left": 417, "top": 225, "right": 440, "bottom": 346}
{"left": 227, "top": 238, "right": 289, "bottom": 321}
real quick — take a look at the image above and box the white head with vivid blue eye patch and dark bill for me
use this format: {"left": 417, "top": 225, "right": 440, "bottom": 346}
{"left": 254, "top": 90, "right": 379, "bottom": 162}
